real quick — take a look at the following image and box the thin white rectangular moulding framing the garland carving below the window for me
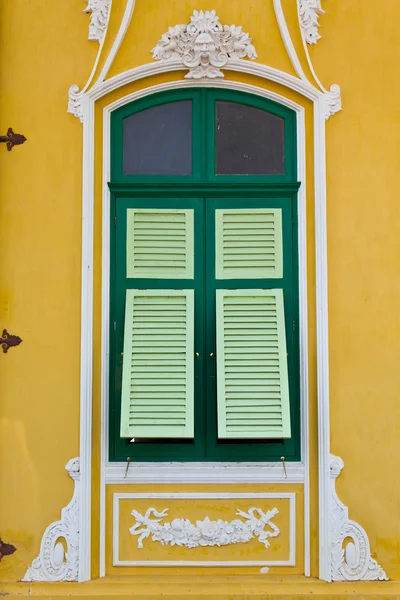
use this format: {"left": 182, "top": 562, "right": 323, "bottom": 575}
{"left": 112, "top": 492, "right": 296, "bottom": 567}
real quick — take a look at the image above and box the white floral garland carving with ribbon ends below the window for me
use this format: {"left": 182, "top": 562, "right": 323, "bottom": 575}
{"left": 129, "top": 507, "right": 280, "bottom": 548}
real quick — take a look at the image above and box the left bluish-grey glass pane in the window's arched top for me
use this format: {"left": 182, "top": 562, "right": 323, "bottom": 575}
{"left": 123, "top": 100, "right": 192, "bottom": 175}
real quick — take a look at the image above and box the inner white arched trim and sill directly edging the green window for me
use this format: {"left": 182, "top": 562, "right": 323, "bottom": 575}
{"left": 100, "top": 75, "right": 310, "bottom": 576}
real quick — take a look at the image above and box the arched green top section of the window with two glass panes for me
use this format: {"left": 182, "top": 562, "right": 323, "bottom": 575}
{"left": 111, "top": 89, "right": 296, "bottom": 183}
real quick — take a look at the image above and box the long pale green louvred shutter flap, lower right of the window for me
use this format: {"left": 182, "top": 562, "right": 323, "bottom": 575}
{"left": 217, "top": 290, "right": 290, "bottom": 438}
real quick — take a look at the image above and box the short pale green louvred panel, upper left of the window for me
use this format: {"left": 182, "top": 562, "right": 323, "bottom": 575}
{"left": 126, "top": 208, "right": 194, "bottom": 279}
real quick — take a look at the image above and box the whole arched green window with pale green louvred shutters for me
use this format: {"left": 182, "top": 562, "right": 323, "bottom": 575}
{"left": 109, "top": 89, "right": 300, "bottom": 461}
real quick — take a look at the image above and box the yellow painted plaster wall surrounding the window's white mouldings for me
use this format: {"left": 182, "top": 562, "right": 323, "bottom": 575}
{"left": 0, "top": 0, "right": 400, "bottom": 592}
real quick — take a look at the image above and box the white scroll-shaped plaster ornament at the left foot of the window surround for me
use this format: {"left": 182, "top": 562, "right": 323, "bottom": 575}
{"left": 22, "top": 457, "right": 80, "bottom": 581}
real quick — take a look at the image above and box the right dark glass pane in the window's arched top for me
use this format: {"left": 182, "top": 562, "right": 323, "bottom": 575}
{"left": 215, "top": 102, "right": 285, "bottom": 175}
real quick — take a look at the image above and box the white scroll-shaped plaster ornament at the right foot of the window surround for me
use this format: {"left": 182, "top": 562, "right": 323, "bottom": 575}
{"left": 330, "top": 454, "right": 387, "bottom": 581}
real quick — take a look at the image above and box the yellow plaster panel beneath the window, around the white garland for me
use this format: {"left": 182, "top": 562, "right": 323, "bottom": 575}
{"left": 106, "top": 484, "right": 304, "bottom": 577}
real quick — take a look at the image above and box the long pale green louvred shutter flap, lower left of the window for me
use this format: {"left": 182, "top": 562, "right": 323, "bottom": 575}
{"left": 121, "top": 290, "right": 194, "bottom": 438}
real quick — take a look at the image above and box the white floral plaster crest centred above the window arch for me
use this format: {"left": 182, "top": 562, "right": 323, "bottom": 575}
{"left": 152, "top": 10, "right": 257, "bottom": 79}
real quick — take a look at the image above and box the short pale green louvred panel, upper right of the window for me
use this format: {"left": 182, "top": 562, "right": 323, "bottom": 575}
{"left": 215, "top": 208, "right": 282, "bottom": 279}
